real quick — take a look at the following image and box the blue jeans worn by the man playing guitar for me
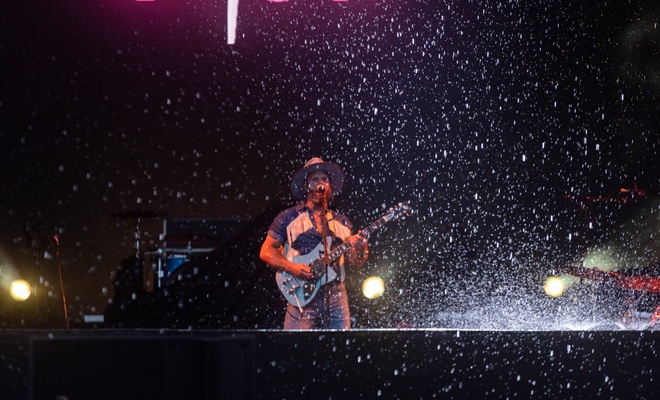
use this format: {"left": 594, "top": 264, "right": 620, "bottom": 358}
{"left": 284, "top": 282, "right": 351, "bottom": 331}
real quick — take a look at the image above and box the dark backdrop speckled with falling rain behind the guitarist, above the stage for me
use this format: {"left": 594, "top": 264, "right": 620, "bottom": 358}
{"left": 0, "top": 0, "right": 660, "bottom": 329}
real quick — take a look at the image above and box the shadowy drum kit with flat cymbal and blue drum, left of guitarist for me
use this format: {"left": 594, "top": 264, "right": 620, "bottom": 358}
{"left": 110, "top": 205, "right": 213, "bottom": 291}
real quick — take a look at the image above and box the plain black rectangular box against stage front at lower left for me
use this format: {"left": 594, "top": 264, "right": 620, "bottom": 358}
{"left": 30, "top": 337, "right": 256, "bottom": 400}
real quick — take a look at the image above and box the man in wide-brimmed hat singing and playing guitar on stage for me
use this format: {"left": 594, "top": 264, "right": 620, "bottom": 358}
{"left": 259, "top": 157, "right": 369, "bottom": 330}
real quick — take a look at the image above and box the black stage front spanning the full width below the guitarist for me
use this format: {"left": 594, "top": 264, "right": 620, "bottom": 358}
{"left": 0, "top": 330, "right": 660, "bottom": 400}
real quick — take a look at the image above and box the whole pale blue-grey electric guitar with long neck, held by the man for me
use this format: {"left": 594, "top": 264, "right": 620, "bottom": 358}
{"left": 275, "top": 202, "right": 412, "bottom": 312}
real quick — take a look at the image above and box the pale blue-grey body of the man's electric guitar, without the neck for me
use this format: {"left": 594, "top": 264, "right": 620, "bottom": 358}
{"left": 275, "top": 243, "right": 337, "bottom": 308}
